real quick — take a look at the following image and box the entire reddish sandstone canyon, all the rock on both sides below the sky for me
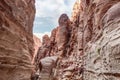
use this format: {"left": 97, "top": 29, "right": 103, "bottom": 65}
{"left": 0, "top": 0, "right": 120, "bottom": 80}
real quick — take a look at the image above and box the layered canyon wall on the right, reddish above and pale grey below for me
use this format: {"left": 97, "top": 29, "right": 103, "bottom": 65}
{"left": 73, "top": 0, "right": 120, "bottom": 80}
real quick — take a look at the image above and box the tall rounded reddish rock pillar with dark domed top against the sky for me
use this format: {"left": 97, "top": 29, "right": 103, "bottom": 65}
{"left": 55, "top": 14, "right": 69, "bottom": 56}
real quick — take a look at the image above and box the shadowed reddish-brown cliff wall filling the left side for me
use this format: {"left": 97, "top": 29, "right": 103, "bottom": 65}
{"left": 0, "top": 0, "right": 35, "bottom": 80}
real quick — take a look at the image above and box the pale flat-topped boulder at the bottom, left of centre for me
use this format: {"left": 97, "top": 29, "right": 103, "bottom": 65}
{"left": 40, "top": 56, "right": 58, "bottom": 80}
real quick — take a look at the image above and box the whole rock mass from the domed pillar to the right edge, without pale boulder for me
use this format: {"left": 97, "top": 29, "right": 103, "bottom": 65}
{"left": 34, "top": 0, "right": 120, "bottom": 80}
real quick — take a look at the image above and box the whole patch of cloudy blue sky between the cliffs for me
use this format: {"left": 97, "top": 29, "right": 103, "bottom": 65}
{"left": 33, "top": 0, "right": 76, "bottom": 38}
